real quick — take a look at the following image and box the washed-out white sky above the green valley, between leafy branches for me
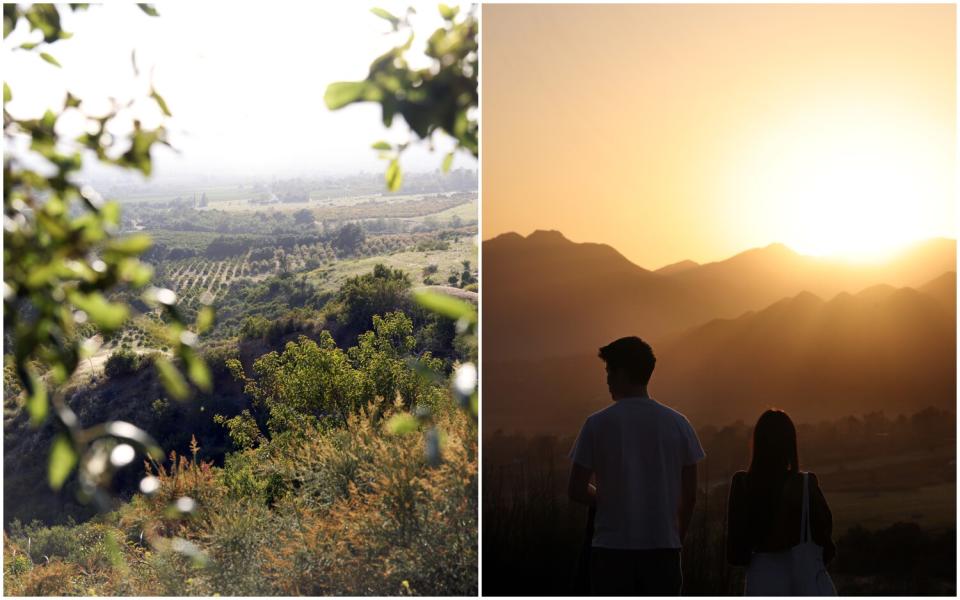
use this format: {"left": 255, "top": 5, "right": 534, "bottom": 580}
{"left": 4, "top": 1, "right": 476, "bottom": 178}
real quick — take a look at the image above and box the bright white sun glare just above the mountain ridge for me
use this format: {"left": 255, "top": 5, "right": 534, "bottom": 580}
{"left": 736, "top": 102, "right": 951, "bottom": 262}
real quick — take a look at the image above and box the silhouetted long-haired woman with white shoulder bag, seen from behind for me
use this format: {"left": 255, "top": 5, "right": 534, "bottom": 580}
{"left": 727, "top": 410, "right": 836, "bottom": 596}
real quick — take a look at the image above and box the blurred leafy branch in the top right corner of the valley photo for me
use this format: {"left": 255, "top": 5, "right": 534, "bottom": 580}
{"left": 324, "top": 4, "right": 480, "bottom": 191}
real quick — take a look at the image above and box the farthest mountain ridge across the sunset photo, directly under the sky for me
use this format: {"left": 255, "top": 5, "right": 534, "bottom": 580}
{"left": 483, "top": 231, "right": 956, "bottom": 359}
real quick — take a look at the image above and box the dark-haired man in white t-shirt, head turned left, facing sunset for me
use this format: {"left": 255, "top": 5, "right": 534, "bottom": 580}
{"left": 569, "top": 337, "right": 704, "bottom": 596}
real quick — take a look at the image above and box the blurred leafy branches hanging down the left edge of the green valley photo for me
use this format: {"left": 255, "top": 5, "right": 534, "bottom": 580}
{"left": 3, "top": 4, "right": 210, "bottom": 507}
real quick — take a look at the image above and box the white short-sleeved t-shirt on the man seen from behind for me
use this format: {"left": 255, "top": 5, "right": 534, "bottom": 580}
{"left": 570, "top": 397, "right": 706, "bottom": 550}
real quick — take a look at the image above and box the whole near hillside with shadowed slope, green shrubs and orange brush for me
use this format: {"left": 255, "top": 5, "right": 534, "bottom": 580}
{"left": 4, "top": 266, "right": 477, "bottom": 595}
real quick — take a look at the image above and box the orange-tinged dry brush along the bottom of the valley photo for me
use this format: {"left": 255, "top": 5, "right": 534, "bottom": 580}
{"left": 3, "top": 403, "right": 478, "bottom": 596}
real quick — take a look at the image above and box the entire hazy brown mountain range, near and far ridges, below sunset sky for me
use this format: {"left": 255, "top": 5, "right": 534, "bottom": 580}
{"left": 482, "top": 232, "right": 956, "bottom": 433}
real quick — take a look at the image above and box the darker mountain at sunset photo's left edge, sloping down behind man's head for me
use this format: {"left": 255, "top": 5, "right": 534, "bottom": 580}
{"left": 482, "top": 231, "right": 713, "bottom": 358}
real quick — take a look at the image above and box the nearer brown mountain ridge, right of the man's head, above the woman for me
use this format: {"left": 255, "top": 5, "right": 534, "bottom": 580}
{"left": 652, "top": 282, "right": 957, "bottom": 423}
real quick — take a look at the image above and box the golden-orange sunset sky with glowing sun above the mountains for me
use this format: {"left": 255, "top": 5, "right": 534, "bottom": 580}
{"left": 481, "top": 5, "right": 956, "bottom": 268}
